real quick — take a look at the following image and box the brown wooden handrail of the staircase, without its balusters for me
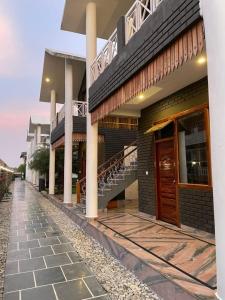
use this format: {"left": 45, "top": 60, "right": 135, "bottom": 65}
{"left": 76, "top": 140, "right": 137, "bottom": 203}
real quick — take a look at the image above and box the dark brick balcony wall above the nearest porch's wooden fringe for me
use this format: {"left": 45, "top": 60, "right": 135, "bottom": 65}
{"left": 89, "top": 0, "right": 201, "bottom": 112}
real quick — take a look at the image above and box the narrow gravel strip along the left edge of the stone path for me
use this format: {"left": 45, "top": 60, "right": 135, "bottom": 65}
{"left": 0, "top": 195, "right": 12, "bottom": 299}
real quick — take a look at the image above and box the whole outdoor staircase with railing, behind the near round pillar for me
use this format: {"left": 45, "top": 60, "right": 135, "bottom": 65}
{"left": 77, "top": 141, "right": 137, "bottom": 213}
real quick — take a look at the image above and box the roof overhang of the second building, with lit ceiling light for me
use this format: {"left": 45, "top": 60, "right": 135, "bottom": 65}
{"left": 40, "top": 49, "right": 86, "bottom": 104}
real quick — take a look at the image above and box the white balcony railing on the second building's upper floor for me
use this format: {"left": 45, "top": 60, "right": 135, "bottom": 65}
{"left": 52, "top": 100, "right": 87, "bottom": 130}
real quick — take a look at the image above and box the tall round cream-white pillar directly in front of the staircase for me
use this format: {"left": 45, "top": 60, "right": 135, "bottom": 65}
{"left": 86, "top": 1, "right": 98, "bottom": 218}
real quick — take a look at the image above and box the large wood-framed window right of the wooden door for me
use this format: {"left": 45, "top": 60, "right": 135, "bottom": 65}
{"left": 177, "top": 111, "right": 209, "bottom": 185}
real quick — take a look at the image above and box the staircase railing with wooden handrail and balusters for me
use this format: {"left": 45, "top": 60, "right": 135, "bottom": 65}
{"left": 76, "top": 141, "right": 137, "bottom": 203}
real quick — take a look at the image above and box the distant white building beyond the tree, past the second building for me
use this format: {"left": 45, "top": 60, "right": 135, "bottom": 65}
{"left": 26, "top": 116, "right": 50, "bottom": 186}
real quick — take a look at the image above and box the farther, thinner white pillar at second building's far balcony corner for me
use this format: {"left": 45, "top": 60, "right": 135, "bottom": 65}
{"left": 49, "top": 90, "right": 56, "bottom": 195}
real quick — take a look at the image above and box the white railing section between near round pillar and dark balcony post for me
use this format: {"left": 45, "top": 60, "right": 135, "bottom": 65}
{"left": 91, "top": 29, "right": 118, "bottom": 83}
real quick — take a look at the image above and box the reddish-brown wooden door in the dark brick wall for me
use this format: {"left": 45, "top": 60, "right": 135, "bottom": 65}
{"left": 156, "top": 139, "right": 179, "bottom": 225}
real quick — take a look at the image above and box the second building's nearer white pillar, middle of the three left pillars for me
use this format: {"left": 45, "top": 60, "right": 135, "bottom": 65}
{"left": 64, "top": 60, "right": 73, "bottom": 205}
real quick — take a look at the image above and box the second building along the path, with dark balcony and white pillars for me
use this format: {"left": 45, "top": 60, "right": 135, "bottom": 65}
{"left": 40, "top": 49, "right": 137, "bottom": 208}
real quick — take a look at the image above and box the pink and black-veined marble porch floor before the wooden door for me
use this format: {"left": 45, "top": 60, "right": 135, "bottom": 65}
{"left": 98, "top": 213, "right": 216, "bottom": 289}
